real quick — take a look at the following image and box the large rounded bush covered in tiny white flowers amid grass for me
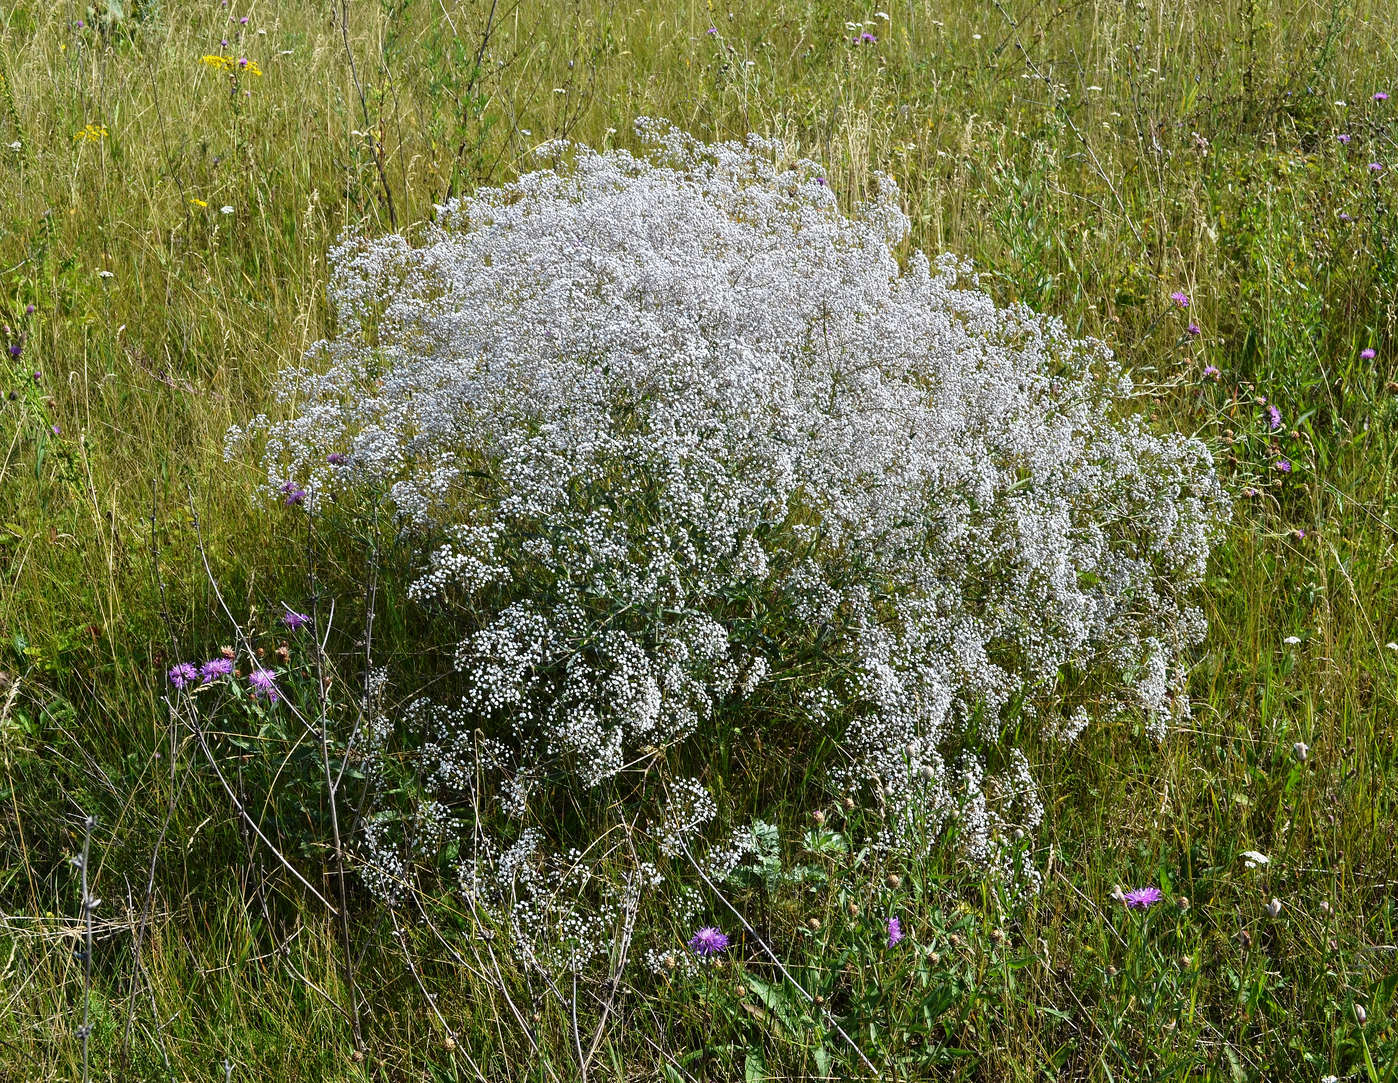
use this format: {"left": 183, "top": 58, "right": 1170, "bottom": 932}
{"left": 235, "top": 122, "right": 1223, "bottom": 967}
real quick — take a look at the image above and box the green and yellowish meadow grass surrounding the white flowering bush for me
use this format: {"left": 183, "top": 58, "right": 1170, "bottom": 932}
{"left": 0, "top": 0, "right": 1398, "bottom": 1080}
